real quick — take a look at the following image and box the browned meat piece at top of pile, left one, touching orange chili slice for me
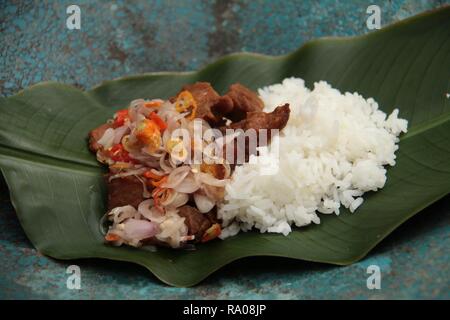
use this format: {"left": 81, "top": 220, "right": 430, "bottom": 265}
{"left": 171, "top": 82, "right": 222, "bottom": 125}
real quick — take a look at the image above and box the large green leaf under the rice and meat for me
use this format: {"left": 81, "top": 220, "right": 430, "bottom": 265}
{"left": 0, "top": 7, "right": 450, "bottom": 286}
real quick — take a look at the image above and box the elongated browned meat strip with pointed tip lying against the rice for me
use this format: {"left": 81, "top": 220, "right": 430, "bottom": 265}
{"left": 220, "top": 103, "right": 290, "bottom": 164}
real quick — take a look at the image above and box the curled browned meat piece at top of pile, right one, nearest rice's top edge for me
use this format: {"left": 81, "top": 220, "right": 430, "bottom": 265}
{"left": 214, "top": 83, "right": 264, "bottom": 121}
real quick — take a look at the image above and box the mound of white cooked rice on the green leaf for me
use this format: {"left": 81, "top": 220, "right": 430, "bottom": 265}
{"left": 218, "top": 78, "right": 408, "bottom": 238}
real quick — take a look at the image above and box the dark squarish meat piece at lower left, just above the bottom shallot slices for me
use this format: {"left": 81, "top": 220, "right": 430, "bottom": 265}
{"left": 106, "top": 175, "right": 145, "bottom": 211}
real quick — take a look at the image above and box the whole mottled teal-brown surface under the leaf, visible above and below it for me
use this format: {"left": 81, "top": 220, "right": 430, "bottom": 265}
{"left": 0, "top": 0, "right": 450, "bottom": 299}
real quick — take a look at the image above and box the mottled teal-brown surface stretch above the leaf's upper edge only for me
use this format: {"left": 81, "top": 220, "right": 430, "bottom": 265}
{"left": 0, "top": 0, "right": 449, "bottom": 95}
